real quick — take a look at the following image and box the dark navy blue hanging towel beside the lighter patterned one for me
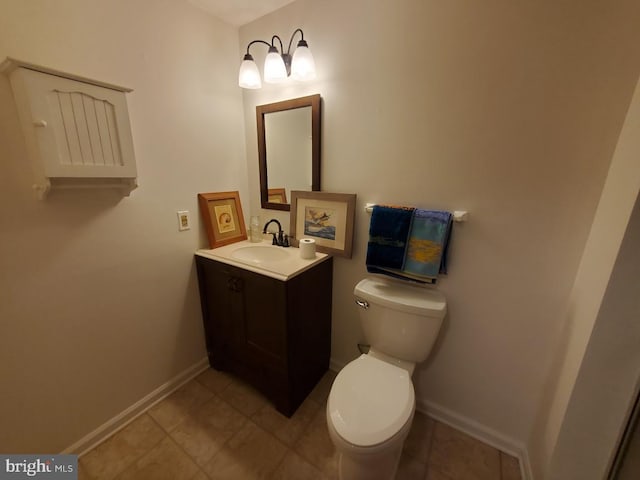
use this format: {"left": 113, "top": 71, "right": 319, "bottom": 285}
{"left": 367, "top": 205, "right": 415, "bottom": 273}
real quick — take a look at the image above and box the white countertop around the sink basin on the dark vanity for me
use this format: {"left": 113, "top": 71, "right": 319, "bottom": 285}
{"left": 196, "top": 240, "right": 329, "bottom": 281}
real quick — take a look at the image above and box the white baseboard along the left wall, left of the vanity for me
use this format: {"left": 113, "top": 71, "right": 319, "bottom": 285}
{"left": 61, "top": 357, "right": 209, "bottom": 456}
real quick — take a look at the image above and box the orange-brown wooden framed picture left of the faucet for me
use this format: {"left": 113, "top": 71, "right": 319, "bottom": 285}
{"left": 198, "top": 192, "right": 247, "bottom": 248}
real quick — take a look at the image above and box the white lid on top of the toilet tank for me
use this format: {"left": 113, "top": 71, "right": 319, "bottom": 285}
{"left": 353, "top": 278, "right": 447, "bottom": 318}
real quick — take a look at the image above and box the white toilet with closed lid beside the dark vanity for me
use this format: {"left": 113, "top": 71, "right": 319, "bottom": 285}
{"left": 327, "top": 278, "right": 447, "bottom": 480}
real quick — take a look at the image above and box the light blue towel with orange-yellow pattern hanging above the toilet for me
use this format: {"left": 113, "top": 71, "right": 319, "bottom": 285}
{"left": 402, "top": 209, "right": 452, "bottom": 283}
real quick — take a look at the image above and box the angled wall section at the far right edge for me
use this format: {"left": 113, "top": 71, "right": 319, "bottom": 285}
{"left": 531, "top": 75, "right": 640, "bottom": 480}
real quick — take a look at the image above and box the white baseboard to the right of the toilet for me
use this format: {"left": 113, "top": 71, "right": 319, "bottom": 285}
{"left": 416, "top": 399, "right": 533, "bottom": 480}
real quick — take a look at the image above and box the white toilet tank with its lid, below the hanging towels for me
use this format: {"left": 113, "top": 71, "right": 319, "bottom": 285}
{"left": 353, "top": 278, "right": 447, "bottom": 363}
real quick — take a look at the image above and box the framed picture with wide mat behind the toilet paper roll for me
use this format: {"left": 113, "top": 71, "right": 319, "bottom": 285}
{"left": 291, "top": 190, "right": 356, "bottom": 258}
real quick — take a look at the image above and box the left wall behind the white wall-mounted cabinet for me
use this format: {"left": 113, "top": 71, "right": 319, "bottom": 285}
{"left": 0, "top": 0, "right": 249, "bottom": 453}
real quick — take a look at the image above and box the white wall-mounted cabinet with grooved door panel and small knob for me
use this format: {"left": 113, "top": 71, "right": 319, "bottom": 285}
{"left": 0, "top": 59, "right": 137, "bottom": 199}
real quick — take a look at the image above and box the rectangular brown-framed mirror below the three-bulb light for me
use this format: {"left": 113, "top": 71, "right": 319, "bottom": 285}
{"left": 256, "top": 95, "right": 320, "bottom": 211}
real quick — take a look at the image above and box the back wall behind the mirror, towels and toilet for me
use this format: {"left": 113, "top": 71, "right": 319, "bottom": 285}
{"left": 240, "top": 0, "right": 640, "bottom": 466}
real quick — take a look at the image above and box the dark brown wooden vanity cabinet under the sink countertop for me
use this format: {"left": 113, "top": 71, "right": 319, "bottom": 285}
{"left": 195, "top": 255, "right": 333, "bottom": 417}
